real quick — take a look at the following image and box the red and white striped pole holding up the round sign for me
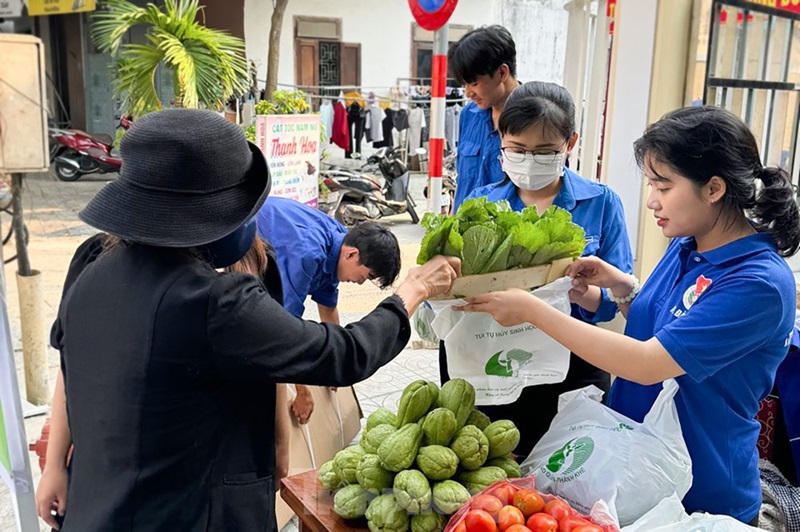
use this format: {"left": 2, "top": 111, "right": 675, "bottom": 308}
{"left": 428, "top": 24, "right": 450, "bottom": 213}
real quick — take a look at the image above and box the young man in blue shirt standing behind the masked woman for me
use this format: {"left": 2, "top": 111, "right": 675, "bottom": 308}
{"left": 454, "top": 26, "right": 519, "bottom": 212}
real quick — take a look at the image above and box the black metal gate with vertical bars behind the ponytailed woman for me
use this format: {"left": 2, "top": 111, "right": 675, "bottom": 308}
{"left": 703, "top": 0, "right": 800, "bottom": 185}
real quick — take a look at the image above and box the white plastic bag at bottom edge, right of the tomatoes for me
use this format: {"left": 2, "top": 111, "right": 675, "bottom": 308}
{"left": 622, "top": 493, "right": 760, "bottom": 532}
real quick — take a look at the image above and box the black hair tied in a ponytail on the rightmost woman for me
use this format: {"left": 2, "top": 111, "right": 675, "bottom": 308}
{"left": 633, "top": 106, "right": 800, "bottom": 257}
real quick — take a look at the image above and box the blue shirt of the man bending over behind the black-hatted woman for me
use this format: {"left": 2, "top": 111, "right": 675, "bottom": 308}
{"left": 256, "top": 197, "right": 347, "bottom": 317}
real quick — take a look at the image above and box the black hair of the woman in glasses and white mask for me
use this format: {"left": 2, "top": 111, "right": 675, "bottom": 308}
{"left": 497, "top": 81, "right": 575, "bottom": 139}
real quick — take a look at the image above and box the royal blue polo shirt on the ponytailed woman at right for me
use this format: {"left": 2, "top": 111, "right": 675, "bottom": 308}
{"left": 608, "top": 234, "right": 795, "bottom": 522}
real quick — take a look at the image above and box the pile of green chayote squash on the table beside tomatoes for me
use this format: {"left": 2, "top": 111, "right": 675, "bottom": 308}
{"left": 319, "top": 379, "right": 520, "bottom": 532}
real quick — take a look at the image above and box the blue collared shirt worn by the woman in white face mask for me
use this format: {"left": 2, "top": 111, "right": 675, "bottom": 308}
{"left": 466, "top": 168, "right": 633, "bottom": 323}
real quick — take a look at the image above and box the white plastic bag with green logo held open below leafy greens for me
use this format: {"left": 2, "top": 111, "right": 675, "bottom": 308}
{"left": 430, "top": 277, "right": 571, "bottom": 405}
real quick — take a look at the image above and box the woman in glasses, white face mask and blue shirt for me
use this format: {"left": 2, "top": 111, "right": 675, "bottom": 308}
{"left": 439, "top": 81, "right": 633, "bottom": 458}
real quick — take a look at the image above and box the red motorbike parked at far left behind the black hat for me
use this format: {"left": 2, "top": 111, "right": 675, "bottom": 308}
{"left": 50, "top": 116, "right": 131, "bottom": 181}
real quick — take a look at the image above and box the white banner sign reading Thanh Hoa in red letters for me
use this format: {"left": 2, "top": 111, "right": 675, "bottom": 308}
{"left": 256, "top": 114, "right": 320, "bottom": 207}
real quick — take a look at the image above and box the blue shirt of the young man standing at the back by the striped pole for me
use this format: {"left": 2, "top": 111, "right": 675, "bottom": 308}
{"left": 453, "top": 102, "right": 505, "bottom": 212}
